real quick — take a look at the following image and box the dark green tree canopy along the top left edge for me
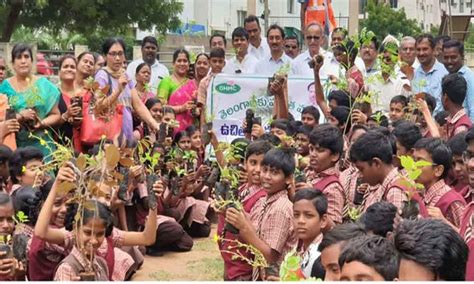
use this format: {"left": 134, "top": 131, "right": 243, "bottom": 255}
{"left": 0, "top": 0, "right": 183, "bottom": 41}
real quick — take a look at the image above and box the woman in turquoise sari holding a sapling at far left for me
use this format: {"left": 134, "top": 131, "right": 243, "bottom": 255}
{"left": 0, "top": 43, "right": 61, "bottom": 157}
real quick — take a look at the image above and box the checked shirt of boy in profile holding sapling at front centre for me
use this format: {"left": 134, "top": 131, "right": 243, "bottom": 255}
{"left": 250, "top": 190, "right": 298, "bottom": 280}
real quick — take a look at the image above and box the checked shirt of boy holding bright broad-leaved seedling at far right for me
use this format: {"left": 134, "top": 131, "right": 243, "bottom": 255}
{"left": 423, "top": 179, "right": 465, "bottom": 228}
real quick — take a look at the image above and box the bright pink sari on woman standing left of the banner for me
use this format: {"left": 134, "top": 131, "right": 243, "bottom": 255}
{"left": 168, "top": 80, "right": 198, "bottom": 134}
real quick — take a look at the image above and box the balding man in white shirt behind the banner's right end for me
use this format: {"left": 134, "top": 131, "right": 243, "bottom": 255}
{"left": 292, "top": 23, "right": 339, "bottom": 79}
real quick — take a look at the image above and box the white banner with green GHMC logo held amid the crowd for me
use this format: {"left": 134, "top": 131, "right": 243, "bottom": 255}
{"left": 206, "top": 74, "right": 324, "bottom": 143}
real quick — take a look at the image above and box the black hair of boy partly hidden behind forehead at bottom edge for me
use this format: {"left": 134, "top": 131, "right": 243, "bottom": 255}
{"left": 318, "top": 223, "right": 367, "bottom": 252}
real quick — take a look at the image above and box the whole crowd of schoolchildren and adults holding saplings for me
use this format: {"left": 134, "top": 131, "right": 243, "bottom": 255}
{"left": 0, "top": 12, "right": 474, "bottom": 281}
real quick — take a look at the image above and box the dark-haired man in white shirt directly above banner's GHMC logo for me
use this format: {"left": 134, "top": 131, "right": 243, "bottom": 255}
{"left": 223, "top": 27, "right": 258, "bottom": 74}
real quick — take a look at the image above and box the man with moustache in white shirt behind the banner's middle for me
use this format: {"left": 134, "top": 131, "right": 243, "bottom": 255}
{"left": 256, "top": 25, "right": 292, "bottom": 76}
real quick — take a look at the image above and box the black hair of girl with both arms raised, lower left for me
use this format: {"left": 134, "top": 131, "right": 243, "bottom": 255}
{"left": 64, "top": 200, "right": 114, "bottom": 237}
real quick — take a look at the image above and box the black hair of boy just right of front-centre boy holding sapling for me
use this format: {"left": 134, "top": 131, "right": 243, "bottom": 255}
{"left": 309, "top": 124, "right": 344, "bottom": 156}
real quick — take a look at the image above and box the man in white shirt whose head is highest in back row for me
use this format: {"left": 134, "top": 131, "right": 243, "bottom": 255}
{"left": 244, "top": 15, "right": 270, "bottom": 60}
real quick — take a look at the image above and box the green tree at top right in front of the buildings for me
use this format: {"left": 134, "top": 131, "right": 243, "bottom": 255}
{"left": 361, "top": 0, "right": 421, "bottom": 40}
